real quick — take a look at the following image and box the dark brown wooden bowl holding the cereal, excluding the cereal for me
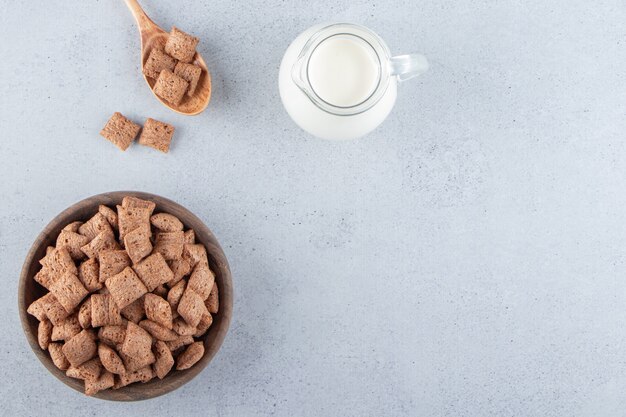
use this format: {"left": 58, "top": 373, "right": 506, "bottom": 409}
{"left": 18, "top": 191, "right": 233, "bottom": 401}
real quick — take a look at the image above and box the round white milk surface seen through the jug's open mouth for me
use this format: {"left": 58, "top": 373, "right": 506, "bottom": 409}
{"left": 308, "top": 35, "right": 380, "bottom": 107}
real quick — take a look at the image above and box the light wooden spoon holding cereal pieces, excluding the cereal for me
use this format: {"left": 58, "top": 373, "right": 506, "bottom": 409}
{"left": 124, "top": 0, "right": 211, "bottom": 116}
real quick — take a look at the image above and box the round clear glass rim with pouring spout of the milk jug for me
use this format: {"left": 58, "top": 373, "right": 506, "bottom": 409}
{"left": 291, "top": 23, "right": 391, "bottom": 116}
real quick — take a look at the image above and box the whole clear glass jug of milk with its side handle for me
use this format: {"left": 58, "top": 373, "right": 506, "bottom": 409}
{"left": 279, "top": 23, "right": 428, "bottom": 140}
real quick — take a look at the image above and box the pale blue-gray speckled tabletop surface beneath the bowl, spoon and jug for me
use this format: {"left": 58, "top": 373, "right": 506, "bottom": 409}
{"left": 0, "top": 0, "right": 626, "bottom": 416}
